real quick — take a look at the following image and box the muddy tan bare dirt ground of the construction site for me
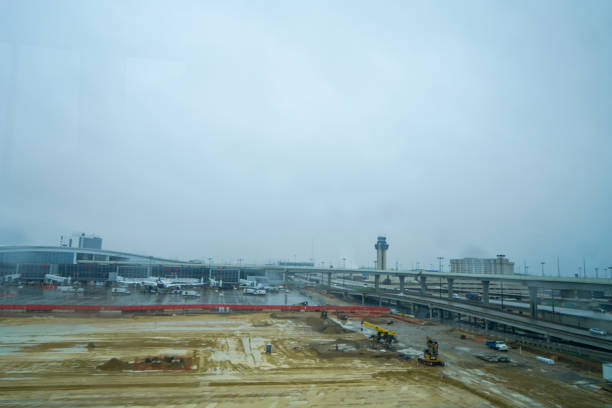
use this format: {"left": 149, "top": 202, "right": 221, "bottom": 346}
{"left": 0, "top": 313, "right": 612, "bottom": 408}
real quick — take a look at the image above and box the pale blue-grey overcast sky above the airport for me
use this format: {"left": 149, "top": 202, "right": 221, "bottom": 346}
{"left": 0, "top": 0, "right": 612, "bottom": 275}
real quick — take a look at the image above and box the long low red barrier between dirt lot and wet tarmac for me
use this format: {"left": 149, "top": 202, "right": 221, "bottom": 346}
{"left": 0, "top": 304, "right": 389, "bottom": 312}
